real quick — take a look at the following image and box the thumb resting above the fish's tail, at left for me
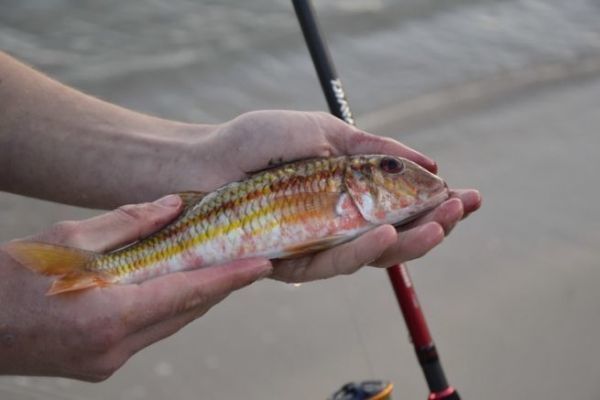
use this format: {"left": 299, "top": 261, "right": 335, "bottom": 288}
{"left": 35, "top": 195, "right": 182, "bottom": 252}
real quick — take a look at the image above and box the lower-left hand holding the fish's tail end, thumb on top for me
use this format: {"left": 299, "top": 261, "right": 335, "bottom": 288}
{"left": 0, "top": 196, "right": 271, "bottom": 382}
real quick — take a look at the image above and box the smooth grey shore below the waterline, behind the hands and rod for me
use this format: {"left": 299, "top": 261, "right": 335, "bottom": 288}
{"left": 0, "top": 72, "right": 600, "bottom": 400}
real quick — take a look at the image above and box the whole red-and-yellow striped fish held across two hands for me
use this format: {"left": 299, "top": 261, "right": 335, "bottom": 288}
{"left": 3, "top": 154, "right": 449, "bottom": 295}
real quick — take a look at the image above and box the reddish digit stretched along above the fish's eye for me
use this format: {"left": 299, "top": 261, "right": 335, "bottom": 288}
{"left": 330, "top": 126, "right": 437, "bottom": 173}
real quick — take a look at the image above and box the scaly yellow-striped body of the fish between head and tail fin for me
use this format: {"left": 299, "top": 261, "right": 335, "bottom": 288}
{"left": 95, "top": 158, "right": 345, "bottom": 282}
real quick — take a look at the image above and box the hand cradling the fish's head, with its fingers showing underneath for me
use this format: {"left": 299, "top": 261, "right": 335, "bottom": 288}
{"left": 196, "top": 111, "right": 481, "bottom": 282}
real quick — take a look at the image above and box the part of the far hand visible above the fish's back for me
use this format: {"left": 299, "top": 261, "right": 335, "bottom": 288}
{"left": 192, "top": 110, "right": 437, "bottom": 191}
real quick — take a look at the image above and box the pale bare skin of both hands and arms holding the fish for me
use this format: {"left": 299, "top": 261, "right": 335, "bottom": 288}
{"left": 0, "top": 53, "right": 481, "bottom": 381}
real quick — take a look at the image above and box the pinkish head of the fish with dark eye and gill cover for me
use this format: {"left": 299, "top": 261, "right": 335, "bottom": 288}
{"left": 344, "top": 155, "right": 449, "bottom": 225}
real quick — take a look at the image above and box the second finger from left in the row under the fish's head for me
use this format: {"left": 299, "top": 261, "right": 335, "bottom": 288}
{"left": 371, "top": 222, "right": 444, "bottom": 267}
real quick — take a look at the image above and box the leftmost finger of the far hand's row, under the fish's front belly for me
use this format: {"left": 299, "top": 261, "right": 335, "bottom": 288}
{"left": 271, "top": 225, "right": 397, "bottom": 282}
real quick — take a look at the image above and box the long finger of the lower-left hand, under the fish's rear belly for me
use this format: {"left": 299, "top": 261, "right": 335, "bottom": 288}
{"left": 122, "top": 258, "right": 272, "bottom": 333}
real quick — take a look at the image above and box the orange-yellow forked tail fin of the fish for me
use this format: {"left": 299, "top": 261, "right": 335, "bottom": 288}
{"left": 2, "top": 241, "right": 113, "bottom": 295}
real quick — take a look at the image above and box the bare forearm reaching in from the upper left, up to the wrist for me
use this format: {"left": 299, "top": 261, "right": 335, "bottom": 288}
{"left": 0, "top": 52, "right": 211, "bottom": 208}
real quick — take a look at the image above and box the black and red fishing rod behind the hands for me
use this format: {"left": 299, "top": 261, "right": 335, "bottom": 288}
{"left": 292, "top": 0, "right": 460, "bottom": 400}
